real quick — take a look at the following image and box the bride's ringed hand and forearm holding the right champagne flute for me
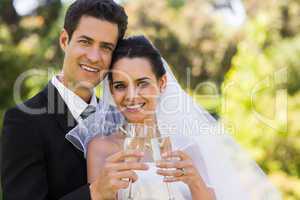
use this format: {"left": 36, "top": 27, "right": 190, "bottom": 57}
{"left": 157, "top": 150, "right": 214, "bottom": 200}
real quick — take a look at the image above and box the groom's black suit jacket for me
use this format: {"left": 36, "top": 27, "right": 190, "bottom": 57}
{"left": 1, "top": 82, "right": 90, "bottom": 200}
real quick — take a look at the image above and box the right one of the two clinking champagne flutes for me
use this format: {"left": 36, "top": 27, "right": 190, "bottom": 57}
{"left": 151, "top": 136, "right": 175, "bottom": 200}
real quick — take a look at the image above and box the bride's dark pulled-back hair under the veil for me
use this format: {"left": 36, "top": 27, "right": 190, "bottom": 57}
{"left": 108, "top": 35, "right": 166, "bottom": 81}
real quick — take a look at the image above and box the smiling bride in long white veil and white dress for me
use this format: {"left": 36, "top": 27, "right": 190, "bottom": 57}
{"left": 67, "top": 36, "right": 282, "bottom": 200}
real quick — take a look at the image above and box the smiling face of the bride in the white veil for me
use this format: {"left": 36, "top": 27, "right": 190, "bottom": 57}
{"left": 111, "top": 58, "right": 166, "bottom": 123}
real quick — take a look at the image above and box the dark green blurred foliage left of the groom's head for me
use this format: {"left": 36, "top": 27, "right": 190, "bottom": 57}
{"left": 0, "top": 0, "right": 63, "bottom": 115}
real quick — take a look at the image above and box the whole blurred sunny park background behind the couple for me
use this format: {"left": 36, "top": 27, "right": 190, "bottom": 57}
{"left": 0, "top": 0, "right": 300, "bottom": 200}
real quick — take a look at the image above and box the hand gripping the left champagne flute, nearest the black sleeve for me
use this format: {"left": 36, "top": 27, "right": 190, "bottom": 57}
{"left": 90, "top": 151, "right": 148, "bottom": 200}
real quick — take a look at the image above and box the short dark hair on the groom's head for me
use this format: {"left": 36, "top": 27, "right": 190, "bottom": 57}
{"left": 64, "top": 0, "right": 128, "bottom": 39}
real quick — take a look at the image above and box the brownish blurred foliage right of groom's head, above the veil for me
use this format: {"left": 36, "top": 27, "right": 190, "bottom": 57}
{"left": 126, "top": 0, "right": 238, "bottom": 92}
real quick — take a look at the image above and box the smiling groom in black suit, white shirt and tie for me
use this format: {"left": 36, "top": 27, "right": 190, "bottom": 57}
{"left": 1, "top": 0, "right": 127, "bottom": 200}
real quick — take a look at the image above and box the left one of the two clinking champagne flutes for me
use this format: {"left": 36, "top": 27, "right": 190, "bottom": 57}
{"left": 124, "top": 123, "right": 147, "bottom": 200}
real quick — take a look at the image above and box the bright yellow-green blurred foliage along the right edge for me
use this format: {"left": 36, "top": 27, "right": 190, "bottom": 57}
{"left": 220, "top": 0, "right": 300, "bottom": 199}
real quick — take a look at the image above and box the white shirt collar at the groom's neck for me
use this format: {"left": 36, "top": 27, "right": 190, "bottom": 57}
{"left": 51, "top": 76, "right": 97, "bottom": 122}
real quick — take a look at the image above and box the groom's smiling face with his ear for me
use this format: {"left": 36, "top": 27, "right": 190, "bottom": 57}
{"left": 60, "top": 16, "right": 118, "bottom": 90}
